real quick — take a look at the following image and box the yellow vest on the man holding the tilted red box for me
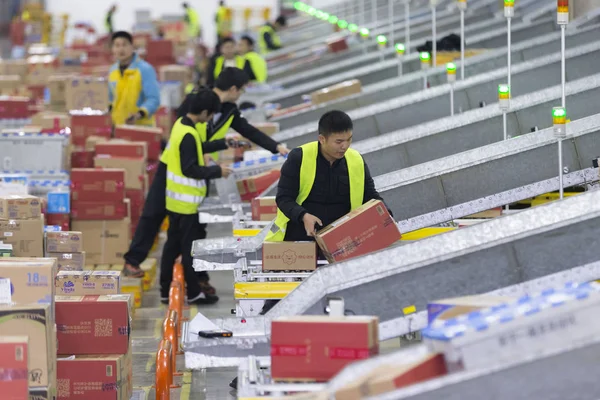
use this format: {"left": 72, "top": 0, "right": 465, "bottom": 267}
{"left": 265, "top": 142, "right": 365, "bottom": 242}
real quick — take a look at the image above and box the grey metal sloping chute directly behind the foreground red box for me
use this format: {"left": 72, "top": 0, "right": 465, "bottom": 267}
{"left": 184, "top": 191, "right": 600, "bottom": 362}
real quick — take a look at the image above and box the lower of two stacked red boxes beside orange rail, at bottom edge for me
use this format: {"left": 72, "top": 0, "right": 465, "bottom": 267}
{"left": 57, "top": 355, "right": 131, "bottom": 400}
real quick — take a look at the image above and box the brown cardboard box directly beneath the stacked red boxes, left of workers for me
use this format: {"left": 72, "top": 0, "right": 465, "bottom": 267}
{"left": 73, "top": 219, "right": 130, "bottom": 264}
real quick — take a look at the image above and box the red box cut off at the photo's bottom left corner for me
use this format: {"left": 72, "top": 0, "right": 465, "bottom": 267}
{"left": 0, "top": 336, "right": 29, "bottom": 400}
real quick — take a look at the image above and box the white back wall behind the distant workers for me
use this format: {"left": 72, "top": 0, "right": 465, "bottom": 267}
{"left": 46, "top": 0, "right": 282, "bottom": 47}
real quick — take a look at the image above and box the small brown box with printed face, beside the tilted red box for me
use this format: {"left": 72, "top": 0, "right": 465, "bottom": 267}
{"left": 263, "top": 242, "right": 317, "bottom": 271}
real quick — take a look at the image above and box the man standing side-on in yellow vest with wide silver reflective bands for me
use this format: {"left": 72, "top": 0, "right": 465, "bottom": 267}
{"left": 160, "top": 90, "right": 231, "bottom": 304}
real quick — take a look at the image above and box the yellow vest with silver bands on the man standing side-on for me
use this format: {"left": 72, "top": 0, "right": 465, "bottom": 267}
{"left": 161, "top": 118, "right": 206, "bottom": 215}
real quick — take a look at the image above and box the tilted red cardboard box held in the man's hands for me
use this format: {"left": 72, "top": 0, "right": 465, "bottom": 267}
{"left": 316, "top": 200, "right": 401, "bottom": 263}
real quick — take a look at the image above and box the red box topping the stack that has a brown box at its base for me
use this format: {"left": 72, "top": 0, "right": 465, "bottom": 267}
{"left": 71, "top": 168, "right": 125, "bottom": 203}
